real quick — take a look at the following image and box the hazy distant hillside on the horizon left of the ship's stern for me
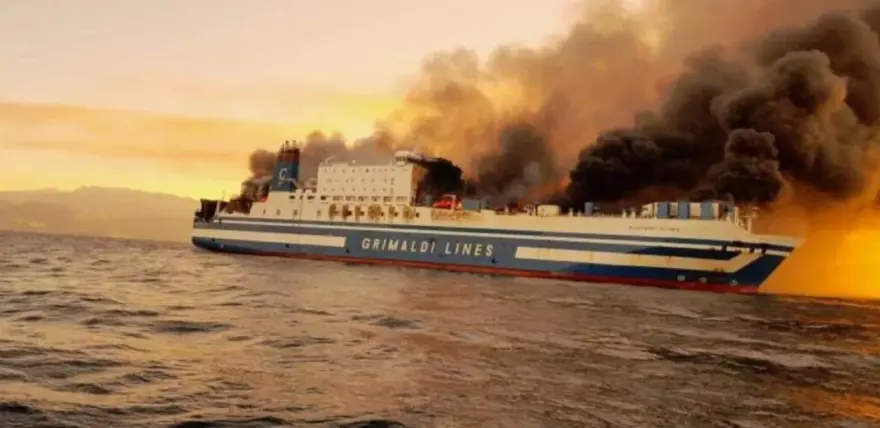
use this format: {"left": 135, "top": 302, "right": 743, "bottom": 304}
{"left": 0, "top": 187, "right": 198, "bottom": 241}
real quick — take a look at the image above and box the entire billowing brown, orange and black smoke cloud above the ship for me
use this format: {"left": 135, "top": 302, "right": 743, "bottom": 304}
{"left": 246, "top": 0, "right": 880, "bottom": 213}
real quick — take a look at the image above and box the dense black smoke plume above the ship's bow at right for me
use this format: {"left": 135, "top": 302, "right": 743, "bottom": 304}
{"left": 568, "top": 2, "right": 880, "bottom": 210}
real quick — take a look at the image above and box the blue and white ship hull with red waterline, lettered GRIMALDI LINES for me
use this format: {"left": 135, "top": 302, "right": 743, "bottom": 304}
{"left": 192, "top": 221, "right": 793, "bottom": 294}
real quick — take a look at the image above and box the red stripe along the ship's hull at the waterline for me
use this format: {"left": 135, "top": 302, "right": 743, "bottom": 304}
{"left": 198, "top": 249, "right": 758, "bottom": 294}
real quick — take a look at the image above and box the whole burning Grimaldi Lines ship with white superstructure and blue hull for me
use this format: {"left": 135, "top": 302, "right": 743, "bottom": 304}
{"left": 192, "top": 142, "right": 801, "bottom": 293}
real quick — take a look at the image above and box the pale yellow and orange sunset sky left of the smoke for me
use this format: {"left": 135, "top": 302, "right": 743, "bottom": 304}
{"left": 0, "top": 0, "right": 579, "bottom": 197}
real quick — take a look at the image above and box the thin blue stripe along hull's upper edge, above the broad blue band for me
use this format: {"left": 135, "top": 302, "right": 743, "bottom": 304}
{"left": 210, "top": 217, "right": 795, "bottom": 252}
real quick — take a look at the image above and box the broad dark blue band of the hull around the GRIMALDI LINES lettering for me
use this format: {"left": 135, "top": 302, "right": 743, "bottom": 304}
{"left": 193, "top": 225, "right": 785, "bottom": 287}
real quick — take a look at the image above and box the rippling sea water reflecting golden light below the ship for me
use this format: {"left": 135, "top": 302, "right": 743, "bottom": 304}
{"left": 0, "top": 232, "right": 880, "bottom": 428}
